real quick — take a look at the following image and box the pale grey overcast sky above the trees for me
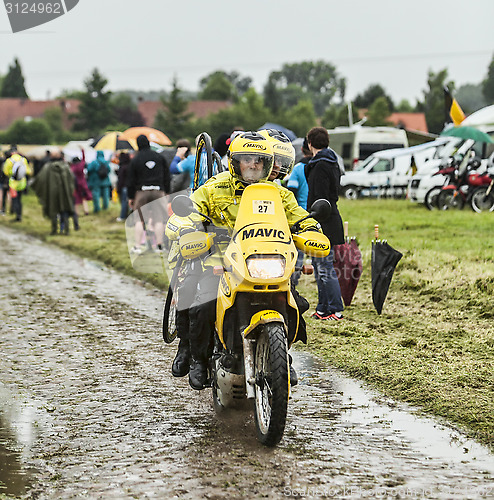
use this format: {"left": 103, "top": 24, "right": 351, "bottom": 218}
{"left": 0, "top": 0, "right": 494, "bottom": 104}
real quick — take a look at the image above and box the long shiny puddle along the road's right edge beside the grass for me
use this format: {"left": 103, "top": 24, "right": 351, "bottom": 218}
{"left": 293, "top": 351, "right": 494, "bottom": 475}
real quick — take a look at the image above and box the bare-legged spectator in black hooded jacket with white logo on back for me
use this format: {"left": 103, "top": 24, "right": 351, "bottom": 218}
{"left": 127, "top": 135, "right": 170, "bottom": 253}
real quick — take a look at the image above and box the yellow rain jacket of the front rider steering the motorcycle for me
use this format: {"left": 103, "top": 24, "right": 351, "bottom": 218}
{"left": 165, "top": 172, "right": 321, "bottom": 266}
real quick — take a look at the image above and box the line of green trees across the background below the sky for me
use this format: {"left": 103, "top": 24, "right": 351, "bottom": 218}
{"left": 0, "top": 56, "right": 494, "bottom": 144}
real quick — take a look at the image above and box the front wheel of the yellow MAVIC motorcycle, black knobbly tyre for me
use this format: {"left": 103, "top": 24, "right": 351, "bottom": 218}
{"left": 255, "top": 323, "right": 289, "bottom": 446}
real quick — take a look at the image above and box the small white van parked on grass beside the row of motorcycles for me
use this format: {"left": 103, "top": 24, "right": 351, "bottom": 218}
{"left": 340, "top": 137, "right": 451, "bottom": 199}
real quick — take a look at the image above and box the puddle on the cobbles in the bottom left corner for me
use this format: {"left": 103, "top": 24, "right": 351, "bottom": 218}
{"left": 0, "top": 386, "right": 35, "bottom": 496}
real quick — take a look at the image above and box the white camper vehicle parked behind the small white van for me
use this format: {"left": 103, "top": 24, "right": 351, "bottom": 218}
{"left": 328, "top": 125, "right": 408, "bottom": 171}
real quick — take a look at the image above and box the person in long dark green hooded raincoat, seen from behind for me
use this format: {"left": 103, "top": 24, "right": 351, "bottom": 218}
{"left": 32, "top": 150, "right": 75, "bottom": 234}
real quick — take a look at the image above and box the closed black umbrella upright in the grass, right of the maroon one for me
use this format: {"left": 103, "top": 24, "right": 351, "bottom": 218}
{"left": 371, "top": 226, "right": 403, "bottom": 314}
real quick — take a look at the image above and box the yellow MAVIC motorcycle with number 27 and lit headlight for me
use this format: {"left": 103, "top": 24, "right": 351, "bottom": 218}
{"left": 172, "top": 183, "right": 331, "bottom": 446}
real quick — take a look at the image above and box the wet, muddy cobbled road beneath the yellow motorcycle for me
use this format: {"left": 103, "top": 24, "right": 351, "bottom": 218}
{"left": 0, "top": 229, "right": 494, "bottom": 499}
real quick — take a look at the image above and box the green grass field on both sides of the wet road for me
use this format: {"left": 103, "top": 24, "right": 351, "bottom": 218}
{"left": 0, "top": 195, "right": 494, "bottom": 447}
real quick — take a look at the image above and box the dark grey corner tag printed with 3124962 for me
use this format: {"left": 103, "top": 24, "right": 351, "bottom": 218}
{"left": 4, "top": 0, "right": 79, "bottom": 33}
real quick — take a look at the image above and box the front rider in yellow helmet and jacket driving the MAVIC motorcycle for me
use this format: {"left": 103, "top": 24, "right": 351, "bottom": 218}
{"left": 166, "top": 132, "right": 320, "bottom": 390}
